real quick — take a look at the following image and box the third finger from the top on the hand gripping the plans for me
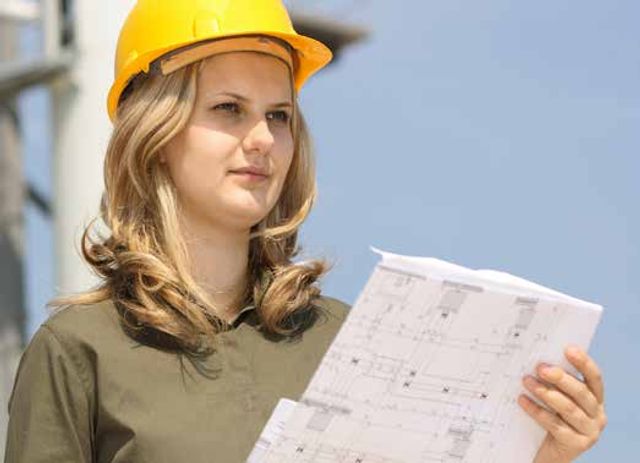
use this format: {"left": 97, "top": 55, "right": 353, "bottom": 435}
{"left": 523, "top": 376, "right": 597, "bottom": 436}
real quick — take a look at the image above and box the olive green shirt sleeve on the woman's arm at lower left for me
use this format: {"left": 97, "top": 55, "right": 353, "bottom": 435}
{"left": 5, "top": 325, "right": 93, "bottom": 463}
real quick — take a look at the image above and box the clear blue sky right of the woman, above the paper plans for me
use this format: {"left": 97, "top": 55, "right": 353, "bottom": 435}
{"left": 301, "top": 0, "right": 640, "bottom": 463}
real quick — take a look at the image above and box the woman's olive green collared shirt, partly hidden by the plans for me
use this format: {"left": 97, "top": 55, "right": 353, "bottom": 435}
{"left": 5, "top": 297, "right": 347, "bottom": 463}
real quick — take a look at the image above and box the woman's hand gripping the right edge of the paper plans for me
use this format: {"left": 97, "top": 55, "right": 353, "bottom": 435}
{"left": 518, "top": 347, "right": 607, "bottom": 463}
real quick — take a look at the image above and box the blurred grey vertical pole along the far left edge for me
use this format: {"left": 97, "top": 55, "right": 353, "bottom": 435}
{"left": 0, "top": 14, "right": 25, "bottom": 458}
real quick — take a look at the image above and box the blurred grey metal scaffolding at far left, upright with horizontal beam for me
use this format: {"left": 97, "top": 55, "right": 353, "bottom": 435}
{"left": 0, "top": 0, "right": 72, "bottom": 459}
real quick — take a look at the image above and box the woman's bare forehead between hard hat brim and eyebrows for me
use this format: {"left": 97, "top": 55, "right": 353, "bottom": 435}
{"left": 198, "top": 52, "right": 293, "bottom": 100}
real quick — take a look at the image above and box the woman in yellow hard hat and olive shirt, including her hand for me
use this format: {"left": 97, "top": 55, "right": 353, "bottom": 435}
{"left": 6, "top": 0, "right": 604, "bottom": 463}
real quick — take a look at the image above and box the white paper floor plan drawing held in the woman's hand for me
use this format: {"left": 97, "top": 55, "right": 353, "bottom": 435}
{"left": 249, "top": 253, "right": 602, "bottom": 463}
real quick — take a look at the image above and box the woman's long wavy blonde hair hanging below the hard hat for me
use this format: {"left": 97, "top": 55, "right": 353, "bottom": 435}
{"left": 51, "top": 58, "right": 328, "bottom": 355}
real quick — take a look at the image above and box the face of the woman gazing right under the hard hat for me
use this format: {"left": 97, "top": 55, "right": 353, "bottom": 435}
{"left": 161, "top": 52, "right": 294, "bottom": 236}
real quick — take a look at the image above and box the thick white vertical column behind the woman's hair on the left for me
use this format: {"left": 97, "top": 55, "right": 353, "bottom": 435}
{"left": 54, "top": 0, "right": 135, "bottom": 293}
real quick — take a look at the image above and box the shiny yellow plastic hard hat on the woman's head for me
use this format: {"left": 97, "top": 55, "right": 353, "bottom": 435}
{"left": 107, "top": 0, "right": 332, "bottom": 119}
